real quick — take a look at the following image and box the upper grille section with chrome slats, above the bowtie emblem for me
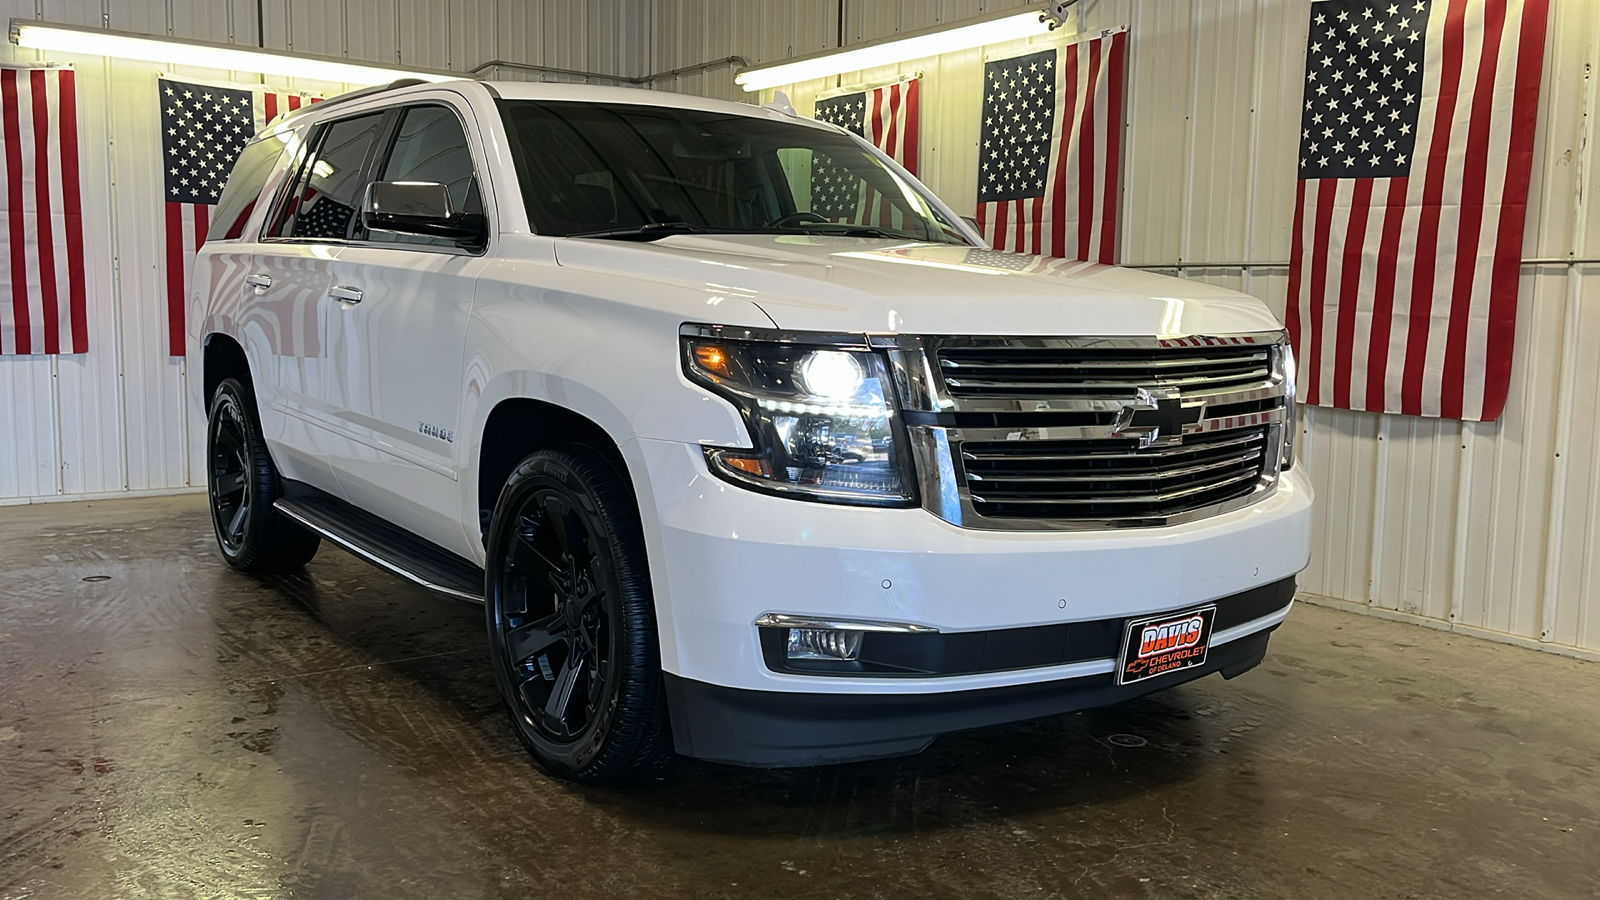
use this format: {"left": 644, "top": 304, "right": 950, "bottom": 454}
{"left": 939, "top": 344, "right": 1272, "bottom": 397}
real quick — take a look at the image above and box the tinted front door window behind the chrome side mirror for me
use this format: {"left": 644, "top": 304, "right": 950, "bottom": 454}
{"left": 368, "top": 106, "right": 483, "bottom": 247}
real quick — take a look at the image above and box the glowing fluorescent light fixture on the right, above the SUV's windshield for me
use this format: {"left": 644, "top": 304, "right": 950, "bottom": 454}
{"left": 733, "top": 10, "right": 1050, "bottom": 91}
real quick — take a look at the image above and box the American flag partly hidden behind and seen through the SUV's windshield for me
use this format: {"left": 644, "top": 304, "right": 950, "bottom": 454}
{"left": 811, "top": 78, "right": 920, "bottom": 227}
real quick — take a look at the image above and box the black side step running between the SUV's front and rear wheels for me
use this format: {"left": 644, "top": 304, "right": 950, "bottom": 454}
{"left": 272, "top": 484, "right": 483, "bottom": 604}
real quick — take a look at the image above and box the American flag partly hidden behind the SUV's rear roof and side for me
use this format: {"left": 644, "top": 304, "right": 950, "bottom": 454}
{"left": 157, "top": 78, "right": 318, "bottom": 356}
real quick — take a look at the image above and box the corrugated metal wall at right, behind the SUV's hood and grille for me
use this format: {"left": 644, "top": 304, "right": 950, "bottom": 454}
{"left": 651, "top": 0, "right": 1600, "bottom": 652}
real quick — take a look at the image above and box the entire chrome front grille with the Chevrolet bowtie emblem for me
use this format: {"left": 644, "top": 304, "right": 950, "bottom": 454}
{"left": 888, "top": 331, "right": 1294, "bottom": 532}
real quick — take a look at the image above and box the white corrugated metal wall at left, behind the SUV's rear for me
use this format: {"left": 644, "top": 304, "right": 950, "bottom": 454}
{"left": 0, "top": 0, "right": 648, "bottom": 503}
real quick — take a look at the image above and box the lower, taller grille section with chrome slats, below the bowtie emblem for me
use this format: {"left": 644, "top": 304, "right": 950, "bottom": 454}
{"left": 962, "top": 426, "right": 1269, "bottom": 519}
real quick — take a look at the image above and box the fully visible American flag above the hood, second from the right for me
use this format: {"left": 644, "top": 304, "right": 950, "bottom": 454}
{"left": 978, "top": 29, "right": 1128, "bottom": 263}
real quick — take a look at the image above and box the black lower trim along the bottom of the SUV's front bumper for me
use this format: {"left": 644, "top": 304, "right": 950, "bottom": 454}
{"left": 666, "top": 628, "right": 1274, "bottom": 767}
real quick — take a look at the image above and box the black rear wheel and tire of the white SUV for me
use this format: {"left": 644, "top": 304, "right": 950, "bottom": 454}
{"left": 206, "top": 378, "right": 322, "bottom": 575}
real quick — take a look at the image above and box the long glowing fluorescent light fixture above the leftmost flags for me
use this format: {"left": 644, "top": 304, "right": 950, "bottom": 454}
{"left": 11, "top": 19, "right": 464, "bottom": 85}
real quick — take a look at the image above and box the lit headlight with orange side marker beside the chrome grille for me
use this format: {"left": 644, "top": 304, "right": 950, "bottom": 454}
{"left": 683, "top": 336, "right": 917, "bottom": 506}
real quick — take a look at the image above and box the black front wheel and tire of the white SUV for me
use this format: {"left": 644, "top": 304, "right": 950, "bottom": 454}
{"left": 485, "top": 448, "right": 670, "bottom": 781}
